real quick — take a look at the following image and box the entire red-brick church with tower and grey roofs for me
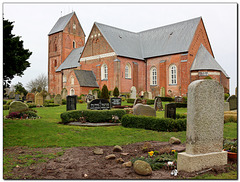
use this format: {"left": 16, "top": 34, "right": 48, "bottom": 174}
{"left": 48, "top": 12, "right": 229, "bottom": 97}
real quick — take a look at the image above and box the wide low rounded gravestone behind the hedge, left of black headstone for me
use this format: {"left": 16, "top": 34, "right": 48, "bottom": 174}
{"left": 133, "top": 104, "right": 156, "bottom": 117}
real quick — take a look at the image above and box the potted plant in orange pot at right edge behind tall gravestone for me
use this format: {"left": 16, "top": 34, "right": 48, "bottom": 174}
{"left": 223, "top": 140, "right": 237, "bottom": 160}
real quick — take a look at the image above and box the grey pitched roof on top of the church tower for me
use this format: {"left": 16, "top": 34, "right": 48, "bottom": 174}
{"left": 48, "top": 12, "right": 74, "bottom": 35}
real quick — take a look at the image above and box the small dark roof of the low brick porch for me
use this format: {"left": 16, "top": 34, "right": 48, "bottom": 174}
{"left": 74, "top": 70, "right": 99, "bottom": 88}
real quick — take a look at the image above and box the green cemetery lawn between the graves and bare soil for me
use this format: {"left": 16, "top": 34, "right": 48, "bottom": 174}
{"left": 3, "top": 101, "right": 237, "bottom": 179}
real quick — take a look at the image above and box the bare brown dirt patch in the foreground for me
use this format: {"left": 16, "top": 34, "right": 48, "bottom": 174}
{"left": 4, "top": 141, "right": 236, "bottom": 179}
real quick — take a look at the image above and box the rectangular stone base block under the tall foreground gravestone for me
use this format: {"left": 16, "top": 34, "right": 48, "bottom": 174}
{"left": 177, "top": 151, "right": 227, "bottom": 172}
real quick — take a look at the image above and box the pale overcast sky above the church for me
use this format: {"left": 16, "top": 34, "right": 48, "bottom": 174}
{"left": 3, "top": 3, "right": 237, "bottom": 94}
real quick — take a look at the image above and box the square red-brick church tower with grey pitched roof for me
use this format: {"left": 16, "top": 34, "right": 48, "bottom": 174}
{"left": 48, "top": 12, "right": 85, "bottom": 95}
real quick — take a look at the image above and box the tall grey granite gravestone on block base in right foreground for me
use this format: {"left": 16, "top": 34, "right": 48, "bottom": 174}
{"left": 177, "top": 80, "right": 227, "bottom": 172}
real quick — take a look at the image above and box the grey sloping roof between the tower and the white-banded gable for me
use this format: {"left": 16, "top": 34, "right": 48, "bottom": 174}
{"left": 56, "top": 47, "right": 83, "bottom": 72}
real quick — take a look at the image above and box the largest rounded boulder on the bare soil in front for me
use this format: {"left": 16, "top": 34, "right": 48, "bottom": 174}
{"left": 133, "top": 160, "right": 152, "bottom": 176}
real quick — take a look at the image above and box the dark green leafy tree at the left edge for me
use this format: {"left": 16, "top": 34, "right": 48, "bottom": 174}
{"left": 3, "top": 20, "right": 32, "bottom": 88}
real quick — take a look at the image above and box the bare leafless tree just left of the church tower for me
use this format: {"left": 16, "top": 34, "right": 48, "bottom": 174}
{"left": 27, "top": 73, "right": 48, "bottom": 93}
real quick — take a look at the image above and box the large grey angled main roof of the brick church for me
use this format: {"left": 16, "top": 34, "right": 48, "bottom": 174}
{"left": 95, "top": 17, "right": 201, "bottom": 60}
